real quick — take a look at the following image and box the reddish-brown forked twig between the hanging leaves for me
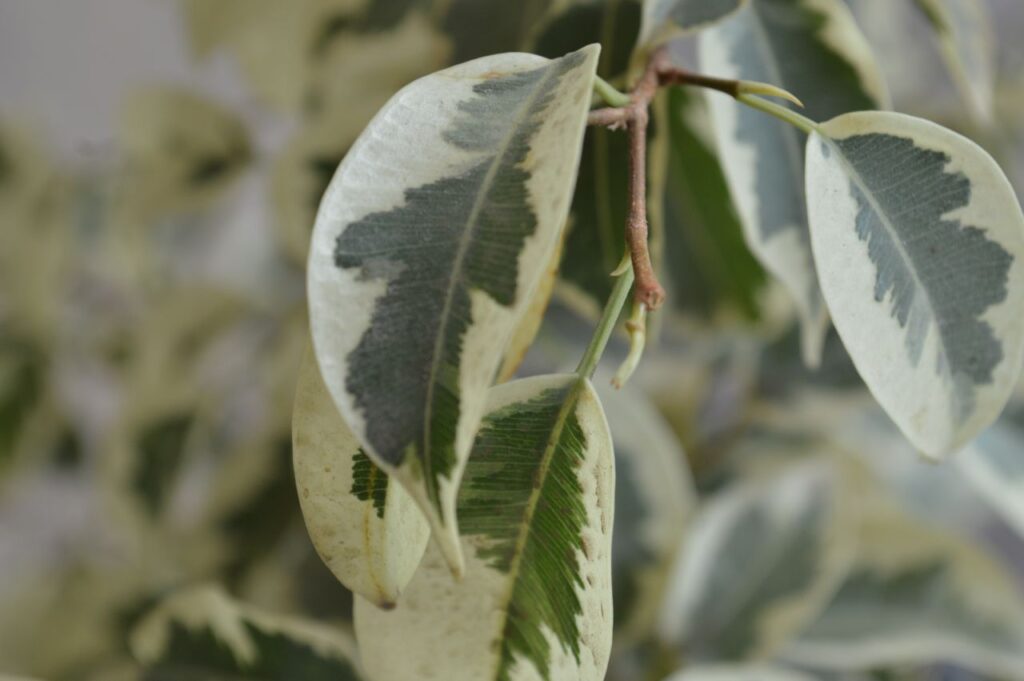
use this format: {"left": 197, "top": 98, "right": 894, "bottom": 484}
{"left": 588, "top": 49, "right": 739, "bottom": 309}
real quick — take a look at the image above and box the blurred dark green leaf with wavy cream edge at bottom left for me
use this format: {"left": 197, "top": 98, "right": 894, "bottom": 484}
{"left": 129, "top": 586, "right": 364, "bottom": 681}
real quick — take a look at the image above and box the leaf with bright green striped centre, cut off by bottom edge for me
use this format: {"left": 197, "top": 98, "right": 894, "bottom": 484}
{"left": 355, "top": 375, "right": 614, "bottom": 681}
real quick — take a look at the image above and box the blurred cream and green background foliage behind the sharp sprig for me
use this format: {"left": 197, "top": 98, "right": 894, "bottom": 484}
{"left": 0, "top": 0, "right": 1024, "bottom": 681}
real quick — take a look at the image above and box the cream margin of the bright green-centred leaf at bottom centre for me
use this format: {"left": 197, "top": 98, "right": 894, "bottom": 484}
{"left": 355, "top": 375, "right": 614, "bottom": 681}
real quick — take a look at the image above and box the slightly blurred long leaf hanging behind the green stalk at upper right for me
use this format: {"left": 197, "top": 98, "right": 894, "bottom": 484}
{"left": 699, "top": 0, "right": 889, "bottom": 367}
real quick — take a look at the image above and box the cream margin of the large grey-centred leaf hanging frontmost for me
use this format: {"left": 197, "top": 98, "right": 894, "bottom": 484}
{"left": 307, "top": 45, "right": 600, "bottom": 574}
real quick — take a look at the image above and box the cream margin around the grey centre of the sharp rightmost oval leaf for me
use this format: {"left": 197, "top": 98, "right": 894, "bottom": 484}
{"left": 807, "top": 112, "right": 1024, "bottom": 458}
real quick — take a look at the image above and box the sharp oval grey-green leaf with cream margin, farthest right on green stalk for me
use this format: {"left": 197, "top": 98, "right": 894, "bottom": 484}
{"left": 807, "top": 112, "right": 1024, "bottom": 457}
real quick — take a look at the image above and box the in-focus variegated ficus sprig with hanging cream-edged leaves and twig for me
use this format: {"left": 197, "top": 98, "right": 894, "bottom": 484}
{"left": 284, "top": 0, "right": 1024, "bottom": 681}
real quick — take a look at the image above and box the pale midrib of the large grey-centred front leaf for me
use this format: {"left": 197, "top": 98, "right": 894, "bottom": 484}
{"left": 423, "top": 63, "right": 555, "bottom": 507}
